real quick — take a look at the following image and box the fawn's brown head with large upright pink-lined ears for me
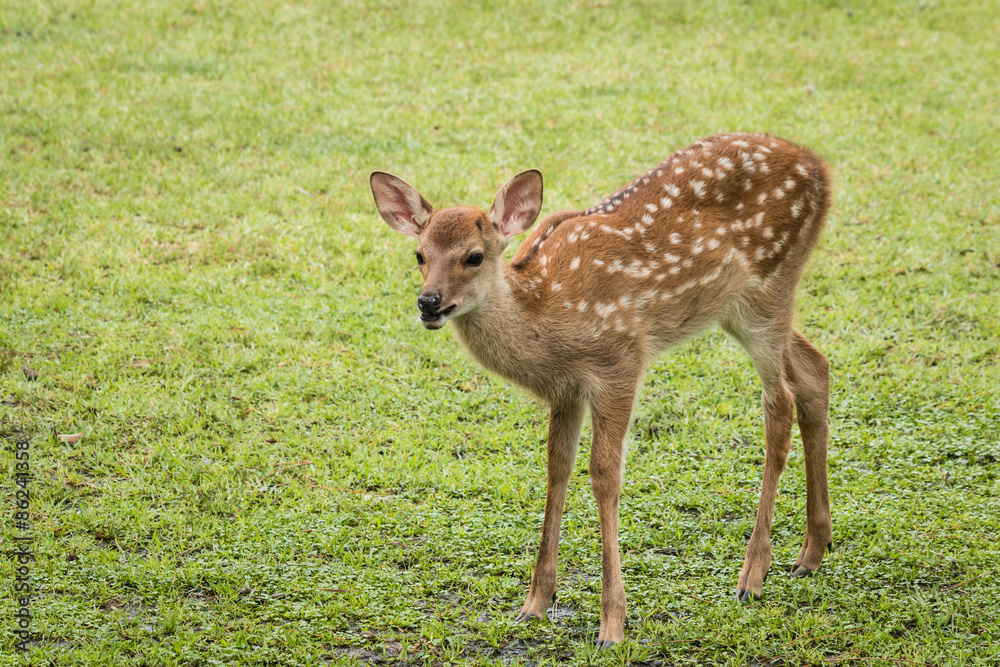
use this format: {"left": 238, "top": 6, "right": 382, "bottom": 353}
{"left": 371, "top": 169, "right": 542, "bottom": 329}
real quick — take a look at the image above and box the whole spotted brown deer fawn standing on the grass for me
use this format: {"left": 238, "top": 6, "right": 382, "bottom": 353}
{"left": 371, "top": 134, "right": 832, "bottom": 646}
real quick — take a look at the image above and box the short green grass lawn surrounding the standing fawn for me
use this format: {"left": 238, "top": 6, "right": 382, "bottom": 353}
{"left": 0, "top": 0, "right": 1000, "bottom": 667}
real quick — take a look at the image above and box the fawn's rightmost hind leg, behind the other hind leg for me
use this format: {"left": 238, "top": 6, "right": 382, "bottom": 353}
{"left": 788, "top": 331, "right": 833, "bottom": 577}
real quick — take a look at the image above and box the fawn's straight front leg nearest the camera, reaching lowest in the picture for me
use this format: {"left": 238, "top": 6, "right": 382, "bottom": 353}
{"left": 590, "top": 387, "right": 635, "bottom": 647}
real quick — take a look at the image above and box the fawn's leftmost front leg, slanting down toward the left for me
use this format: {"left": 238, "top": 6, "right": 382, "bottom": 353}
{"left": 517, "top": 401, "right": 584, "bottom": 621}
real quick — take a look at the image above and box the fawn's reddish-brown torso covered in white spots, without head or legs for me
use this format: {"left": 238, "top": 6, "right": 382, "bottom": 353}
{"left": 511, "top": 134, "right": 829, "bottom": 353}
